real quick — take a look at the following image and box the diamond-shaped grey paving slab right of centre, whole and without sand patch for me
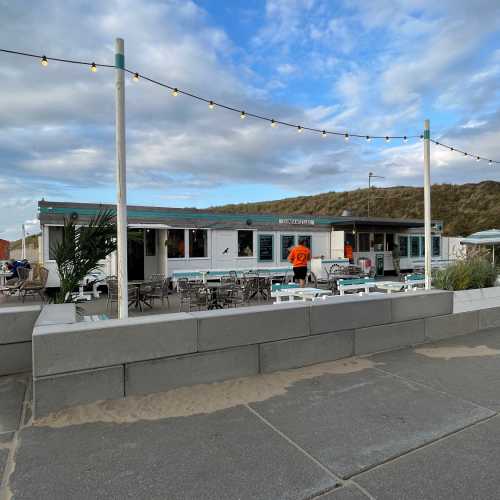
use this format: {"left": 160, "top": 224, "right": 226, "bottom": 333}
{"left": 250, "top": 368, "right": 494, "bottom": 478}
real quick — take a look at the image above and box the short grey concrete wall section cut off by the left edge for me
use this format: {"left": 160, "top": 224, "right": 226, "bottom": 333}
{"left": 0, "top": 306, "right": 40, "bottom": 375}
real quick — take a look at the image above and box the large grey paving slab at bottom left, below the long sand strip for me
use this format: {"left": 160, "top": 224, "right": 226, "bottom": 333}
{"left": 10, "top": 406, "right": 336, "bottom": 500}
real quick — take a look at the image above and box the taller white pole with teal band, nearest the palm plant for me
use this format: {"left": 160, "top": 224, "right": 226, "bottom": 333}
{"left": 115, "top": 38, "right": 128, "bottom": 319}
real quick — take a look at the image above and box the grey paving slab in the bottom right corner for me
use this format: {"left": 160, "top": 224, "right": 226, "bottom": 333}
{"left": 356, "top": 417, "right": 500, "bottom": 500}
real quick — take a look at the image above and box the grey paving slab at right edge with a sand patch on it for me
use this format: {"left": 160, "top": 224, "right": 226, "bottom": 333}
{"left": 370, "top": 330, "right": 500, "bottom": 411}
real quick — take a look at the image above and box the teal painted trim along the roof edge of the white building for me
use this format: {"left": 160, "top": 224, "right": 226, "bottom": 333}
{"left": 40, "top": 207, "right": 336, "bottom": 225}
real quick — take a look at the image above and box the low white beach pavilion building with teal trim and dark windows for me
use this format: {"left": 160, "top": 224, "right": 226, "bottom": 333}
{"left": 38, "top": 200, "right": 458, "bottom": 286}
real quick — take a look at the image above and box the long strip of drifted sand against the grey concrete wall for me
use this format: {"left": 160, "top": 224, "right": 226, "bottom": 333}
{"left": 33, "top": 358, "right": 376, "bottom": 427}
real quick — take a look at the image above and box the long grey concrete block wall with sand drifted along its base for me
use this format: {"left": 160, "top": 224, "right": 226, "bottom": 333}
{"left": 33, "top": 291, "right": 468, "bottom": 417}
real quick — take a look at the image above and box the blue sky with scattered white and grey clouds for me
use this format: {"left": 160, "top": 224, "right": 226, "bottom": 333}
{"left": 0, "top": 0, "right": 500, "bottom": 239}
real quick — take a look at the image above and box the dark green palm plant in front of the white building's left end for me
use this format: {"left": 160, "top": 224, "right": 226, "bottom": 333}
{"left": 51, "top": 210, "right": 116, "bottom": 304}
